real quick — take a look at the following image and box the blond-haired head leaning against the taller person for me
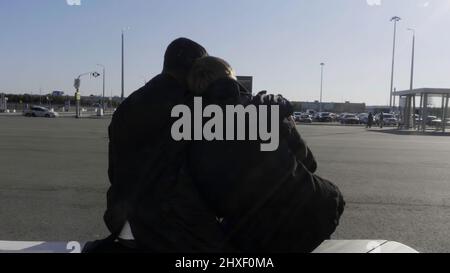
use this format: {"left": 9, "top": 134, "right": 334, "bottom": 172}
{"left": 188, "top": 56, "right": 236, "bottom": 96}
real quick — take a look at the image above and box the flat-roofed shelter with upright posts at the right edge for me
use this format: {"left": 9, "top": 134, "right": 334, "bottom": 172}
{"left": 394, "top": 88, "right": 450, "bottom": 132}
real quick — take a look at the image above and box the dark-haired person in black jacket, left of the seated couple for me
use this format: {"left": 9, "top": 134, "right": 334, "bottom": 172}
{"left": 104, "top": 38, "right": 232, "bottom": 253}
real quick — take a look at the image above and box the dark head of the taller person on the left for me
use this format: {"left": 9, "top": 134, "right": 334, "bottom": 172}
{"left": 163, "top": 38, "right": 208, "bottom": 85}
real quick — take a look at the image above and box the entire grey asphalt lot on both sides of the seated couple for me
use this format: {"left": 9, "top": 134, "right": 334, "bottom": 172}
{"left": 0, "top": 117, "right": 450, "bottom": 252}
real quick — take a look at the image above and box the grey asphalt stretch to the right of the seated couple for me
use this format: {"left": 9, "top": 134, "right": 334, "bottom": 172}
{"left": 300, "top": 126, "right": 450, "bottom": 252}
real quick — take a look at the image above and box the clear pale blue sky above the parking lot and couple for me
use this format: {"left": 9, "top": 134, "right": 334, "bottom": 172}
{"left": 0, "top": 0, "right": 450, "bottom": 104}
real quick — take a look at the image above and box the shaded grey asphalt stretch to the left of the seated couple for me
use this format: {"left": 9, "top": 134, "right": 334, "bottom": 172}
{"left": 0, "top": 117, "right": 109, "bottom": 241}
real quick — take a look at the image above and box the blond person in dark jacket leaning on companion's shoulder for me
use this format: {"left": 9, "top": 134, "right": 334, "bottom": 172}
{"left": 186, "top": 57, "right": 345, "bottom": 253}
